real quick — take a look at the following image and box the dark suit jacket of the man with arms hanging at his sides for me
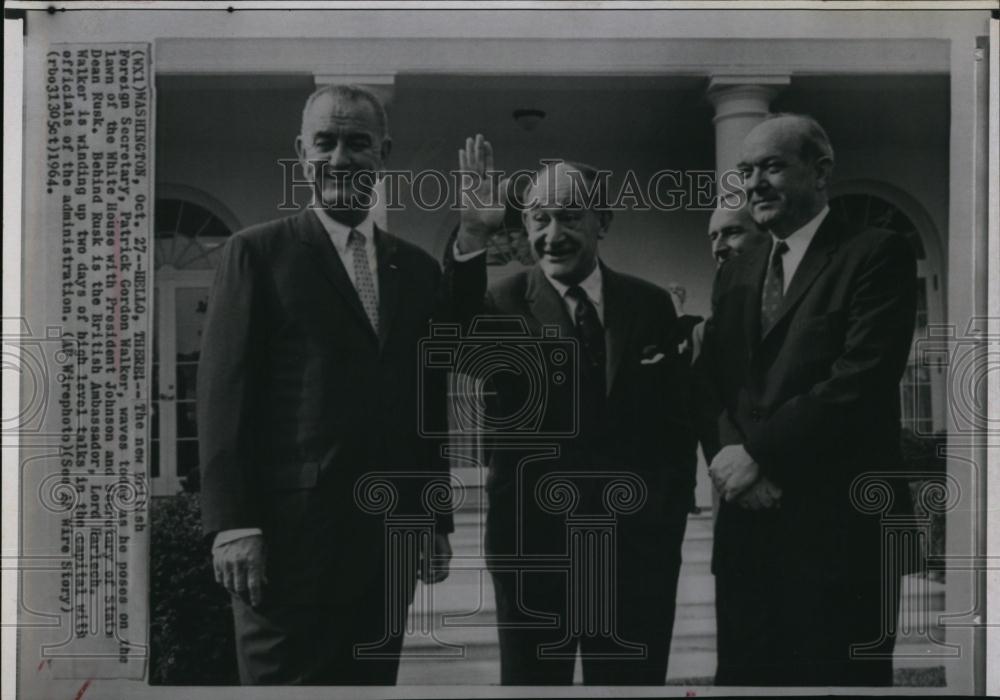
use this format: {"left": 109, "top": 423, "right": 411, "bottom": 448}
{"left": 198, "top": 210, "right": 450, "bottom": 600}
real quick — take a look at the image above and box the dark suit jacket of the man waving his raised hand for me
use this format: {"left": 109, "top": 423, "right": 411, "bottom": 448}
{"left": 445, "top": 254, "right": 696, "bottom": 576}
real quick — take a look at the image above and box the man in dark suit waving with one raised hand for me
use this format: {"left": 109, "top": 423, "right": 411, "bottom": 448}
{"left": 445, "top": 136, "right": 696, "bottom": 685}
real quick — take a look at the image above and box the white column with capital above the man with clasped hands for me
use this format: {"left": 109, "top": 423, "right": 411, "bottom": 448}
{"left": 707, "top": 75, "right": 790, "bottom": 189}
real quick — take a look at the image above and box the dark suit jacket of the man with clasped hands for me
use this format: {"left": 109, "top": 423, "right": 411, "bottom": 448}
{"left": 703, "top": 214, "right": 916, "bottom": 578}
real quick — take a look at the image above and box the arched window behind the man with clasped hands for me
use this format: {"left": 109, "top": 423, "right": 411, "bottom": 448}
{"left": 830, "top": 181, "right": 946, "bottom": 435}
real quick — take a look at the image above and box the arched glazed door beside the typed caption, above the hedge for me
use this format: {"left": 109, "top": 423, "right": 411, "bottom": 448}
{"left": 150, "top": 185, "right": 239, "bottom": 495}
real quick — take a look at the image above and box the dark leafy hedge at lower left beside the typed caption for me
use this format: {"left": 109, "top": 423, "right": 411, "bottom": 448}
{"left": 149, "top": 493, "right": 239, "bottom": 685}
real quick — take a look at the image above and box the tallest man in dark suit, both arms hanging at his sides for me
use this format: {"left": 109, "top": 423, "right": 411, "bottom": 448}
{"left": 198, "top": 86, "right": 451, "bottom": 684}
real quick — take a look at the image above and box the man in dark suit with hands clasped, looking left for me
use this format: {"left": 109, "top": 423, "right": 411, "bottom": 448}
{"left": 703, "top": 115, "right": 916, "bottom": 686}
